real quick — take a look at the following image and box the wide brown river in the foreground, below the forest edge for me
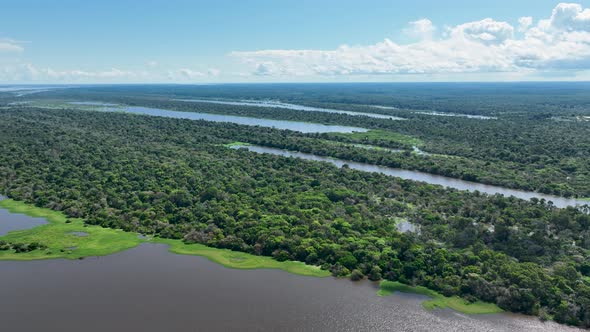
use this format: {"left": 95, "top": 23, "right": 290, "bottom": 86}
{"left": 0, "top": 211, "right": 578, "bottom": 332}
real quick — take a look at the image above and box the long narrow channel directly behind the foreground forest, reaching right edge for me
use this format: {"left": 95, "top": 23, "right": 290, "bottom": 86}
{"left": 232, "top": 145, "right": 590, "bottom": 208}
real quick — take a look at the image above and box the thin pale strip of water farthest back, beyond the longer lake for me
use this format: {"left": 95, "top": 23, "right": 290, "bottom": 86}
{"left": 174, "top": 99, "right": 405, "bottom": 120}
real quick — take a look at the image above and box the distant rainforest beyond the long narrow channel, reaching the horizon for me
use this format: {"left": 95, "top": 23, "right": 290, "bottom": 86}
{"left": 26, "top": 83, "right": 590, "bottom": 197}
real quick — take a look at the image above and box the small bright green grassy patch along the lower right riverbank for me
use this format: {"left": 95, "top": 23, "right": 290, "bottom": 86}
{"left": 377, "top": 280, "right": 503, "bottom": 314}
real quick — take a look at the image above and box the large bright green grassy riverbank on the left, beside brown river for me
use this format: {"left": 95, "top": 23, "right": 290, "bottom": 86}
{"left": 0, "top": 199, "right": 330, "bottom": 277}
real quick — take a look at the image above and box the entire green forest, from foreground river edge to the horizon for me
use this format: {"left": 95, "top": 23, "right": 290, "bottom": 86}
{"left": 0, "top": 84, "right": 590, "bottom": 327}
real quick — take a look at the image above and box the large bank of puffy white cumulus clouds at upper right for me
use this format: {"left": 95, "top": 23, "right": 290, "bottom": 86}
{"left": 230, "top": 3, "right": 590, "bottom": 76}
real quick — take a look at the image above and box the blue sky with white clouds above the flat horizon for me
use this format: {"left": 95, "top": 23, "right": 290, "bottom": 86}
{"left": 0, "top": 0, "right": 590, "bottom": 84}
